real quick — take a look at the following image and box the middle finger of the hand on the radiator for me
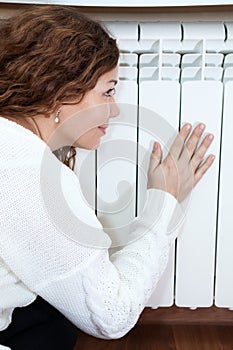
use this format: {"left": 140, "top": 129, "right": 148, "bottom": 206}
{"left": 180, "top": 123, "right": 205, "bottom": 162}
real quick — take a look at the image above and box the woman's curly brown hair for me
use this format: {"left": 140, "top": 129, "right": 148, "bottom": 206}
{"left": 0, "top": 5, "right": 119, "bottom": 171}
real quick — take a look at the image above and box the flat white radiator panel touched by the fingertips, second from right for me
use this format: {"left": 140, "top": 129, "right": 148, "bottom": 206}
{"left": 175, "top": 81, "right": 222, "bottom": 308}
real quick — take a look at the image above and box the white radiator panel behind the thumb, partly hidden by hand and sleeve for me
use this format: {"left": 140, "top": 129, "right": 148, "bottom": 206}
{"left": 138, "top": 80, "right": 180, "bottom": 307}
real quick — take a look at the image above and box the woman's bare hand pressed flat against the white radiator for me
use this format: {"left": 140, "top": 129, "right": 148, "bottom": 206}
{"left": 147, "top": 123, "right": 215, "bottom": 202}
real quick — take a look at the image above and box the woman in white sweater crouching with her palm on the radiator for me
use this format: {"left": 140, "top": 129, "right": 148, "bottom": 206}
{"left": 0, "top": 6, "right": 214, "bottom": 350}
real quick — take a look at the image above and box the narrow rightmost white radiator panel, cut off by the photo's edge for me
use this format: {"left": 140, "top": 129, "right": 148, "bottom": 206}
{"left": 215, "top": 81, "right": 233, "bottom": 308}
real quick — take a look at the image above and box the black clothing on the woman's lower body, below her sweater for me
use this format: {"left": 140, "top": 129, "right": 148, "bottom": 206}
{"left": 0, "top": 296, "right": 78, "bottom": 350}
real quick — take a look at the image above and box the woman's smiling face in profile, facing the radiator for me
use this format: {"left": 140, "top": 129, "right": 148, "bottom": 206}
{"left": 58, "top": 67, "right": 120, "bottom": 149}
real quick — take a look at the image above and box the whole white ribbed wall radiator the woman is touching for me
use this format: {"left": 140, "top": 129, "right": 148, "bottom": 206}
{"left": 74, "top": 21, "right": 233, "bottom": 308}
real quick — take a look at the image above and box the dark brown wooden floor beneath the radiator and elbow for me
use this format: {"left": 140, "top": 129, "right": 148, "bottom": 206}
{"left": 74, "top": 324, "right": 233, "bottom": 350}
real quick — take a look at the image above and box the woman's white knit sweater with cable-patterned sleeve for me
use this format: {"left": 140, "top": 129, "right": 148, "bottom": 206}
{"left": 0, "top": 117, "right": 178, "bottom": 349}
